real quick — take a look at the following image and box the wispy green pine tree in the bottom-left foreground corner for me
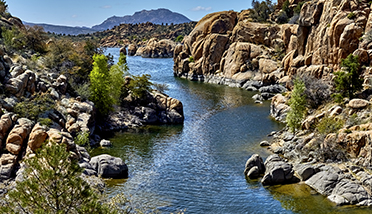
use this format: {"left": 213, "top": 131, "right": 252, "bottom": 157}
{"left": 0, "top": 143, "right": 112, "bottom": 214}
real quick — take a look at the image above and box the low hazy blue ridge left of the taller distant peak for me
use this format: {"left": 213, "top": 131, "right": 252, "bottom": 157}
{"left": 23, "top": 22, "right": 97, "bottom": 35}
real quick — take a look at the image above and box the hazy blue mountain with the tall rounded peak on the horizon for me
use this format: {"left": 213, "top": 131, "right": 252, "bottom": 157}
{"left": 92, "top": 8, "right": 191, "bottom": 31}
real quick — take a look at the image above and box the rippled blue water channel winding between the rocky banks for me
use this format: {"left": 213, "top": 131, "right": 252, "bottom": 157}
{"left": 94, "top": 48, "right": 372, "bottom": 213}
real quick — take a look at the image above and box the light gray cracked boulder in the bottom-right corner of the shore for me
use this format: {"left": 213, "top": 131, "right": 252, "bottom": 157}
{"left": 328, "top": 179, "right": 370, "bottom": 205}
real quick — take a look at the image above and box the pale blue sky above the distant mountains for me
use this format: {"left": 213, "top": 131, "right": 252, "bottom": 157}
{"left": 6, "top": 0, "right": 251, "bottom": 27}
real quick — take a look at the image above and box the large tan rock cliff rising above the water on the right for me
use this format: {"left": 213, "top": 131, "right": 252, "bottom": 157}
{"left": 174, "top": 0, "right": 372, "bottom": 84}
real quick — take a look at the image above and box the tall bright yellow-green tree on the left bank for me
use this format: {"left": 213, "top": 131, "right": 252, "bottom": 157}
{"left": 89, "top": 54, "right": 114, "bottom": 115}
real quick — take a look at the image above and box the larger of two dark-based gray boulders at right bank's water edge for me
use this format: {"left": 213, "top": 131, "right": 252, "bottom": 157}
{"left": 261, "top": 154, "right": 299, "bottom": 185}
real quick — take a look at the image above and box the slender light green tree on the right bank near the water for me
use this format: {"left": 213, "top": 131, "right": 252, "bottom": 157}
{"left": 286, "top": 79, "right": 306, "bottom": 133}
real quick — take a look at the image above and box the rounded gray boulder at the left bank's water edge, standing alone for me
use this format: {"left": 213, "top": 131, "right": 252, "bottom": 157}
{"left": 90, "top": 154, "right": 128, "bottom": 178}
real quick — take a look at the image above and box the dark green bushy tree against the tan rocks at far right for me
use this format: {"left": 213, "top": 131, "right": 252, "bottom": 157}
{"left": 333, "top": 54, "right": 363, "bottom": 102}
